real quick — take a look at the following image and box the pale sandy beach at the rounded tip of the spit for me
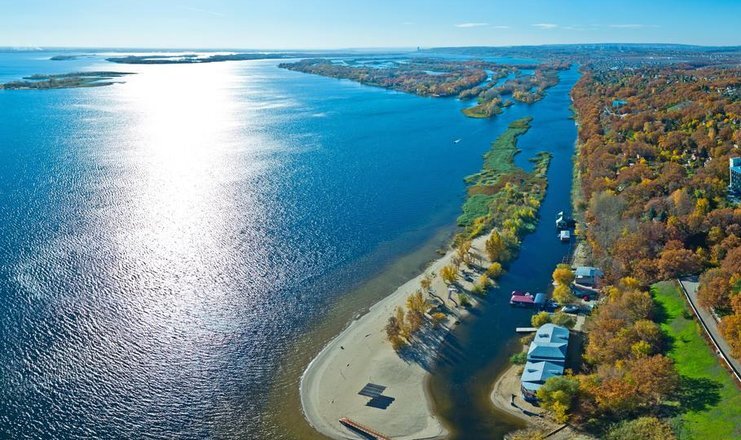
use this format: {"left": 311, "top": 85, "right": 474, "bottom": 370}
{"left": 300, "top": 236, "right": 487, "bottom": 439}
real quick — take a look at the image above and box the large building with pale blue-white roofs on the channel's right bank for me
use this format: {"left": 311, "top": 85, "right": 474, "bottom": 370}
{"left": 520, "top": 324, "right": 569, "bottom": 401}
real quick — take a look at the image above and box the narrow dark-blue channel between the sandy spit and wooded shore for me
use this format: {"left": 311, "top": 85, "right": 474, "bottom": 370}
{"left": 429, "top": 67, "right": 579, "bottom": 439}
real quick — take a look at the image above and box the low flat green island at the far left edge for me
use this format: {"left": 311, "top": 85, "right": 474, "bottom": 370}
{"left": 0, "top": 71, "right": 133, "bottom": 90}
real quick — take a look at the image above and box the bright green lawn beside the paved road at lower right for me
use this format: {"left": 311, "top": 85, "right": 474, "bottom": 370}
{"left": 652, "top": 281, "right": 741, "bottom": 440}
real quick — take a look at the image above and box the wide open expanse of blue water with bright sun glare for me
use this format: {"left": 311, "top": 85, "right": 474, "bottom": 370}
{"left": 0, "top": 52, "right": 560, "bottom": 438}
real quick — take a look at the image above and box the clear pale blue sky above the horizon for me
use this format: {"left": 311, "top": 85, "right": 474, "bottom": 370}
{"left": 0, "top": 0, "right": 741, "bottom": 49}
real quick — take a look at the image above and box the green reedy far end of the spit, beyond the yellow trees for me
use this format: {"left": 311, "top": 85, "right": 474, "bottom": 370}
{"left": 458, "top": 117, "right": 551, "bottom": 238}
